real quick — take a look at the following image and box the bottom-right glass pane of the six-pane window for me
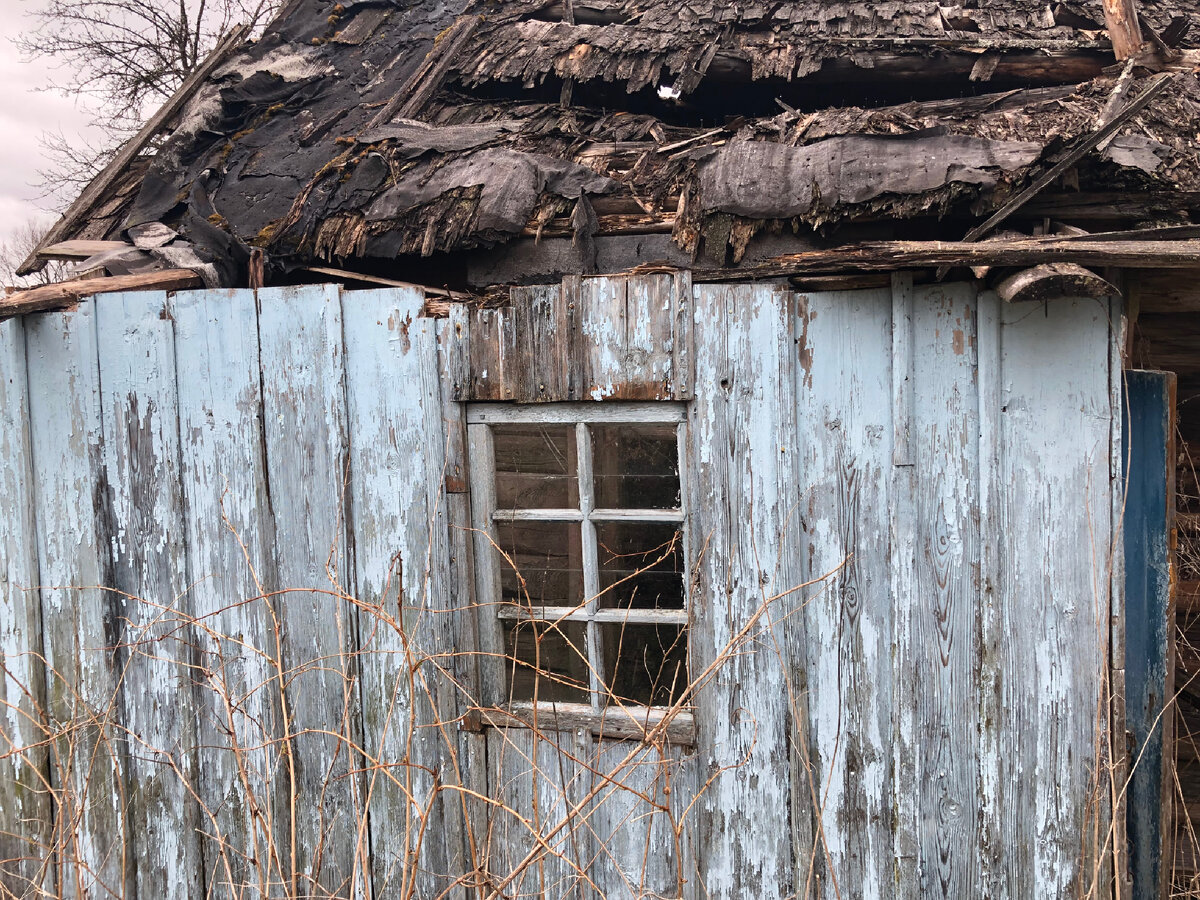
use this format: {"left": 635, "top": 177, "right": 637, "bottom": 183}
{"left": 601, "top": 622, "right": 688, "bottom": 706}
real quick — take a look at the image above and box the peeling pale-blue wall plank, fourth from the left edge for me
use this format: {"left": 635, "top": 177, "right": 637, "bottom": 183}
{"left": 170, "top": 290, "right": 287, "bottom": 898}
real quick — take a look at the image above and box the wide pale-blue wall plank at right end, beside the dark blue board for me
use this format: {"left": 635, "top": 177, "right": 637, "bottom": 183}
{"left": 988, "top": 294, "right": 1120, "bottom": 896}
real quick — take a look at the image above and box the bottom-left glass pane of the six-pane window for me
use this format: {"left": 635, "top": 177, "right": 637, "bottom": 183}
{"left": 504, "top": 620, "right": 589, "bottom": 703}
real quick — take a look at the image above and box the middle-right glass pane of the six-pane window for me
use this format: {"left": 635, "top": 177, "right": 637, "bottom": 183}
{"left": 596, "top": 522, "right": 683, "bottom": 610}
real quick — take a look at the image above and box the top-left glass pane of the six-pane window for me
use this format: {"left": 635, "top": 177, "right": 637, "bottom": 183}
{"left": 492, "top": 425, "right": 580, "bottom": 509}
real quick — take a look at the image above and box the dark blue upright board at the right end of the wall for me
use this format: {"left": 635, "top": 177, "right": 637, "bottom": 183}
{"left": 1122, "top": 371, "right": 1175, "bottom": 898}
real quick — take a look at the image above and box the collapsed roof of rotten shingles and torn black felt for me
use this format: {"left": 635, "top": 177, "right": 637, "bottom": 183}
{"left": 21, "top": 0, "right": 1200, "bottom": 284}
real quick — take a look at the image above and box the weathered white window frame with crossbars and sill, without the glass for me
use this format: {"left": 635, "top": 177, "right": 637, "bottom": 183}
{"left": 467, "top": 401, "right": 695, "bottom": 743}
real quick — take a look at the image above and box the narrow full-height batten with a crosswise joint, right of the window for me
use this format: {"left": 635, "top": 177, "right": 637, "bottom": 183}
{"left": 888, "top": 272, "right": 922, "bottom": 900}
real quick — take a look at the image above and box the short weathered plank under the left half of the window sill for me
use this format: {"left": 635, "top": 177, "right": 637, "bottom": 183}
{"left": 482, "top": 727, "right": 588, "bottom": 900}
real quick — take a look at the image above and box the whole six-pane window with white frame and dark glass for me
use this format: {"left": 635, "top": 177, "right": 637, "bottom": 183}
{"left": 467, "top": 403, "right": 689, "bottom": 737}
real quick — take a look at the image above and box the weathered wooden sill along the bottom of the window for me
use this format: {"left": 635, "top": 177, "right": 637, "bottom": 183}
{"left": 468, "top": 701, "right": 696, "bottom": 746}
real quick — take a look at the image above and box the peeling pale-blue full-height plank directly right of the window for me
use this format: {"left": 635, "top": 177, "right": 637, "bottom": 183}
{"left": 688, "top": 284, "right": 799, "bottom": 898}
